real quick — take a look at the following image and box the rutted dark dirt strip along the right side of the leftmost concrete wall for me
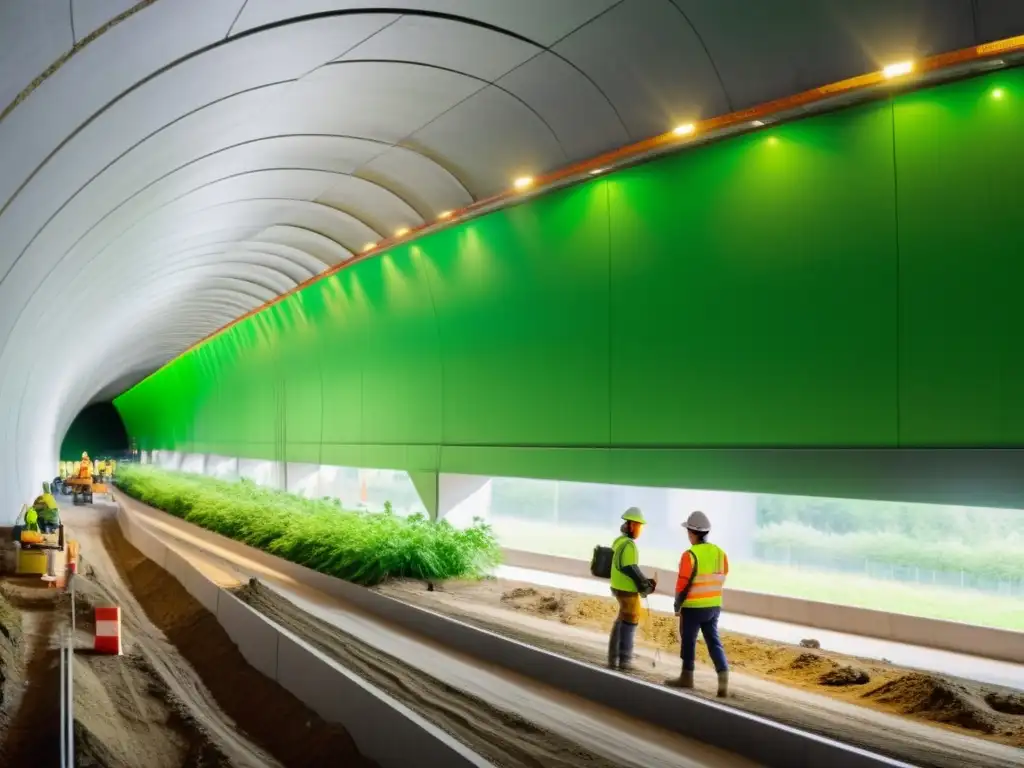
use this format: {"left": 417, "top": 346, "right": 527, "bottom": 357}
{"left": 234, "top": 581, "right": 617, "bottom": 768}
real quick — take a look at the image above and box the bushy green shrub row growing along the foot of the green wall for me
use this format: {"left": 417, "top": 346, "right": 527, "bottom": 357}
{"left": 116, "top": 465, "right": 501, "bottom": 586}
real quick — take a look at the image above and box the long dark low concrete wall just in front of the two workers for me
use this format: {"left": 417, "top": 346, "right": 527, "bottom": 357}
{"left": 119, "top": 498, "right": 910, "bottom": 768}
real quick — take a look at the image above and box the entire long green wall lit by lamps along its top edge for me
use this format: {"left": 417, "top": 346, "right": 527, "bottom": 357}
{"left": 116, "top": 71, "right": 1024, "bottom": 493}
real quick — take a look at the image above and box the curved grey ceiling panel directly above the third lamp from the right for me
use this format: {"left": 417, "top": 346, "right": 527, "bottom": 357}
{"left": 402, "top": 86, "right": 568, "bottom": 198}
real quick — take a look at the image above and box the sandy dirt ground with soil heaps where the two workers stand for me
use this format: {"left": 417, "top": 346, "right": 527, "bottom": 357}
{"left": 379, "top": 580, "right": 1024, "bottom": 768}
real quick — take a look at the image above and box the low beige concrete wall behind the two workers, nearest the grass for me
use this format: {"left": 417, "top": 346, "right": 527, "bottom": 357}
{"left": 503, "top": 550, "right": 1024, "bottom": 664}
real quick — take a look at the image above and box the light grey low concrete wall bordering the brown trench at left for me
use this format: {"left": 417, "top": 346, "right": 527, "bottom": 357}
{"left": 112, "top": 505, "right": 493, "bottom": 768}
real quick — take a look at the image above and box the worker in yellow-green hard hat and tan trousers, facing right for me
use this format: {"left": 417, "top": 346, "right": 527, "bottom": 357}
{"left": 608, "top": 507, "right": 657, "bottom": 672}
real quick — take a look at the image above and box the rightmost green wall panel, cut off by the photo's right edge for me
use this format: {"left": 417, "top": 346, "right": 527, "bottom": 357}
{"left": 895, "top": 70, "right": 1024, "bottom": 445}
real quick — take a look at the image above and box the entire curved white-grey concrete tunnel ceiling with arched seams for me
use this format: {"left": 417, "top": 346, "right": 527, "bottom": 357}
{"left": 0, "top": 0, "right": 1024, "bottom": 514}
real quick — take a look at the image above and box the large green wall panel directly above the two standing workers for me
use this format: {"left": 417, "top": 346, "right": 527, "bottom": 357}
{"left": 608, "top": 103, "right": 896, "bottom": 445}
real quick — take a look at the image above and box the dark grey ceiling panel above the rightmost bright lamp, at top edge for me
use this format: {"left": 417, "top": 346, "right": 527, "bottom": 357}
{"left": 673, "top": 0, "right": 974, "bottom": 109}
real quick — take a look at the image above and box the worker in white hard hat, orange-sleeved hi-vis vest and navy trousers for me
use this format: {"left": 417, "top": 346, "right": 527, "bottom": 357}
{"left": 668, "top": 511, "right": 729, "bottom": 697}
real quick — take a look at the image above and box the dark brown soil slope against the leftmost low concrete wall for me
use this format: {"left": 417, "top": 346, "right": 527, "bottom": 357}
{"left": 94, "top": 524, "right": 374, "bottom": 768}
